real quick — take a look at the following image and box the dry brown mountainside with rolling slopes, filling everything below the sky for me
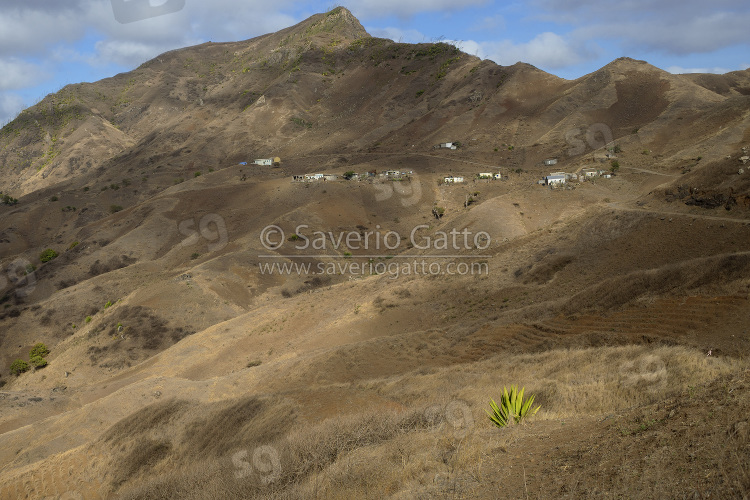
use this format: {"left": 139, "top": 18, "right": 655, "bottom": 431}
{"left": 0, "top": 7, "right": 750, "bottom": 499}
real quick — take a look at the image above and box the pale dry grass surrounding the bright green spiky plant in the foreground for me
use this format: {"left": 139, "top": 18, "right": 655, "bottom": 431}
{"left": 113, "top": 346, "right": 743, "bottom": 499}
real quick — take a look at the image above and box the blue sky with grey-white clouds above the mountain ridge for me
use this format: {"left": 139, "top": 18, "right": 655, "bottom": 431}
{"left": 0, "top": 0, "right": 750, "bottom": 124}
